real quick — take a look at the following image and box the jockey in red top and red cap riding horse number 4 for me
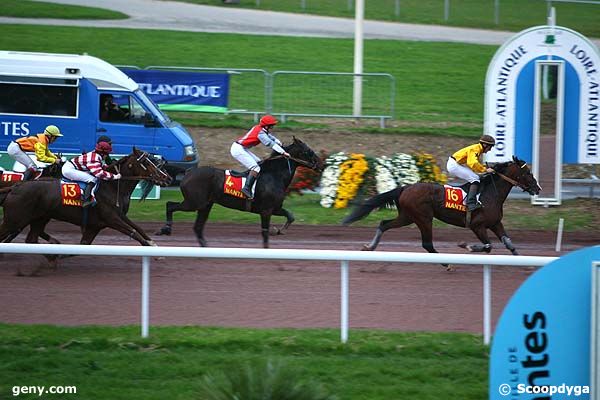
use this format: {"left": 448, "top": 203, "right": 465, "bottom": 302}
{"left": 230, "top": 115, "right": 290, "bottom": 199}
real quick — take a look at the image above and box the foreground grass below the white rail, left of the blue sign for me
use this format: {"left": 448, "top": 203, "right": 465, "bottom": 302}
{"left": 0, "top": 324, "right": 488, "bottom": 400}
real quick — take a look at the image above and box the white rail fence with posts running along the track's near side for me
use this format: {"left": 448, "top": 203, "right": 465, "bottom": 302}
{"left": 0, "top": 243, "right": 557, "bottom": 344}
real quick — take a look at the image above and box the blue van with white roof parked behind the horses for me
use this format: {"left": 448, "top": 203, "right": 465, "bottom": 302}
{"left": 0, "top": 51, "right": 198, "bottom": 176}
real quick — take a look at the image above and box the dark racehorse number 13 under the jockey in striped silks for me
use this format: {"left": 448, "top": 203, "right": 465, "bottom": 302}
{"left": 0, "top": 148, "right": 171, "bottom": 246}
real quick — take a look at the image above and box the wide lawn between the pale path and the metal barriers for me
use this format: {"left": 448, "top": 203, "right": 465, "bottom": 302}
{"left": 0, "top": 25, "right": 496, "bottom": 137}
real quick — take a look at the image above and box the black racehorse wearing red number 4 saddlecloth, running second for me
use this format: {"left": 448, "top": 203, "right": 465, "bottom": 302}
{"left": 156, "top": 137, "right": 323, "bottom": 248}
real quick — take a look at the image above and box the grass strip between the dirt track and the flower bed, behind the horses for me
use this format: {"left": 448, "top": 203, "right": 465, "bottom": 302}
{"left": 127, "top": 190, "right": 600, "bottom": 231}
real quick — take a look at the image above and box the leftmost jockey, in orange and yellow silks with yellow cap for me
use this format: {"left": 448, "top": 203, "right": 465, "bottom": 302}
{"left": 6, "top": 125, "right": 62, "bottom": 181}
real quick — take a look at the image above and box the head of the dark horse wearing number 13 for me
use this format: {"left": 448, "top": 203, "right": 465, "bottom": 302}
{"left": 117, "top": 147, "right": 172, "bottom": 186}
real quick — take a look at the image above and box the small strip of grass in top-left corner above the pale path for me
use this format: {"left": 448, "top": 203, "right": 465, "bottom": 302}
{"left": 0, "top": 0, "right": 129, "bottom": 19}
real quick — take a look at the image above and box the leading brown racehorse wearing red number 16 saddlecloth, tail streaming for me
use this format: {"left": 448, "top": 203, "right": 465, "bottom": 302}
{"left": 342, "top": 156, "right": 541, "bottom": 267}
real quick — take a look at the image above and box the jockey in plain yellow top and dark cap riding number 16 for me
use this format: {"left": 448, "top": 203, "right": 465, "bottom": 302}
{"left": 446, "top": 135, "right": 496, "bottom": 211}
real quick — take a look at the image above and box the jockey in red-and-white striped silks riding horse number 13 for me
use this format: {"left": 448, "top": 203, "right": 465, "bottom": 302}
{"left": 62, "top": 142, "right": 121, "bottom": 207}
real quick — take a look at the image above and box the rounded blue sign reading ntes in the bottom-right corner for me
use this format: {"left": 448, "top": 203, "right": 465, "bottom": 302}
{"left": 489, "top": 246, "right": 600, "bottom": 400}
